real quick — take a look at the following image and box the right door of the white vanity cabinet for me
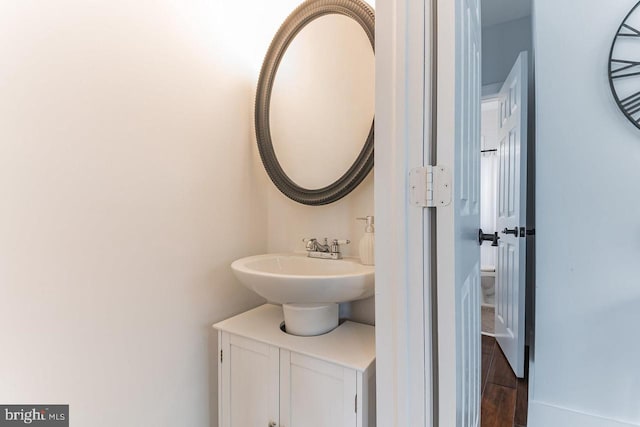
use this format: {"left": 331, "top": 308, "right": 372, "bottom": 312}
{"left": 280, "top": 350, "right": 357, "bottom": 427}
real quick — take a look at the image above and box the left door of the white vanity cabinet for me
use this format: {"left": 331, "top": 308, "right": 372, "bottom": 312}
{"left": 218, "top": 332, "right": 279, "bottom": 427}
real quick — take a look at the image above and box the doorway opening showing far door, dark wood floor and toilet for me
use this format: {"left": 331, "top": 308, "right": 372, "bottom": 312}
{"left": 480, "top": 0, "right": 534, "bottom": 427}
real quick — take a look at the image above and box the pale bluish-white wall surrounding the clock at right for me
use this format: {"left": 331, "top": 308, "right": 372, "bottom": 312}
{"left": 529, "top": 0, "right": 640, "bottom": 427}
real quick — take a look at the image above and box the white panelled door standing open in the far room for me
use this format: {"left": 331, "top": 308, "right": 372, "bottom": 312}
{"left": 495, "top": 52, "right": 528, "bottom": 378}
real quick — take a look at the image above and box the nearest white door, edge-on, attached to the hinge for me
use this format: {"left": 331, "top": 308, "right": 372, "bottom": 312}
{"left": 436, "top": 0, "right": 481, "bottom": 427}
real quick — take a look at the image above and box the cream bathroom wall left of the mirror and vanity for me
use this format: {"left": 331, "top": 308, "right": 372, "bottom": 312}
{"left": 0, "top": 0, "right": 292, "bottom": 427}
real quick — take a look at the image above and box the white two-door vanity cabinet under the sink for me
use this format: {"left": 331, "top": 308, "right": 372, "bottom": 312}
{"left": 214, "top": 304, "right": 375, "bottom": 427}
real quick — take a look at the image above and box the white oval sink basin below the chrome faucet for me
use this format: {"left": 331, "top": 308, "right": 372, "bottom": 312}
{"left": 231, "top": 253, "right": 375, "bottom": 304}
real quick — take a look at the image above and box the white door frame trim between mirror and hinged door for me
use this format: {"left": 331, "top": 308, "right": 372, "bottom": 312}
{"left": 375, "top": 0, "right": 433, "bottom": 427}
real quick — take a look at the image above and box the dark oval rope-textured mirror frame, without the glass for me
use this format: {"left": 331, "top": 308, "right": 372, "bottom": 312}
{"left": 255, "top": 0, "right": 375, "bottom": 206}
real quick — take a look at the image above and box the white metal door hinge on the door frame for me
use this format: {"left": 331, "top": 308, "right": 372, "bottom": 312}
{"left": 409, "top": 165, "right": 451, "bottom": 208}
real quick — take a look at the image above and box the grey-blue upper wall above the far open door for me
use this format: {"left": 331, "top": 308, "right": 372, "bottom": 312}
{"left": 482, "top": 16, "right": 532, "bottom": 85}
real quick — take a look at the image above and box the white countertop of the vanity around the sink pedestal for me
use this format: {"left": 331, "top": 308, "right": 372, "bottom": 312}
{"left": 213, "top": 304, "right": 376, "bottom": 372}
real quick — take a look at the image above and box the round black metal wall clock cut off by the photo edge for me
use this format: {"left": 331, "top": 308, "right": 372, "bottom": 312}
{"left": 609, "top": 2, "right": 640, "bottom": 129}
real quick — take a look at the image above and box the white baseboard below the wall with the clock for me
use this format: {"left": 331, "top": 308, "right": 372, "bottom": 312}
{"left": 528, "top": 401, "right": 640, "bottom": 427}
